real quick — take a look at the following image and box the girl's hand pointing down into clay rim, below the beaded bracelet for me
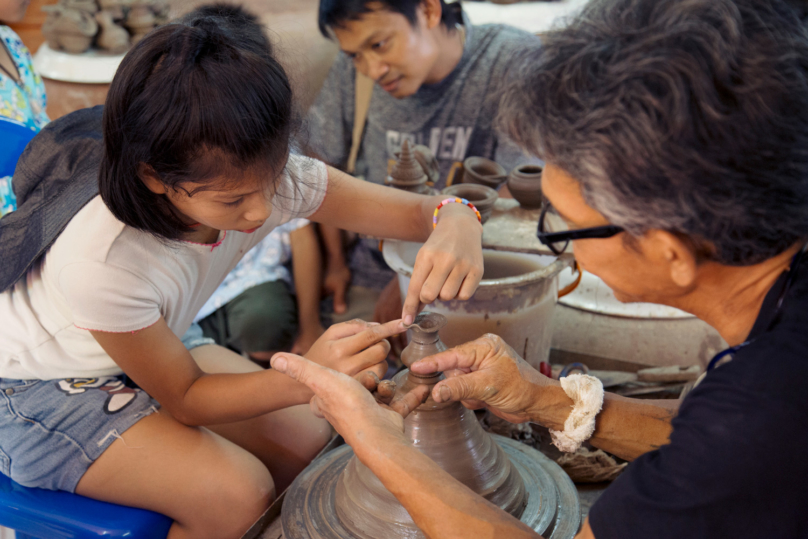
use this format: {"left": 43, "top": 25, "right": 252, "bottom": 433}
{"left": 402, "top": 204, "right": 483, "bottom": 324}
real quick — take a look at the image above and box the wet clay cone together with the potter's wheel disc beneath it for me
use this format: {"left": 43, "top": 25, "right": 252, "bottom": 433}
{"left": 282, "top": 312, "right": 580, "bottom": 539}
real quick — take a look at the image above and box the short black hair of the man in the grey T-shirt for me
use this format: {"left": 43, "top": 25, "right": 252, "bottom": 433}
{"left": 317, "top": 0, "right": 463, "bottom": 39}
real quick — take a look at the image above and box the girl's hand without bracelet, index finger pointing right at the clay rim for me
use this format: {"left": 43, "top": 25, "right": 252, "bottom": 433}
{"left": 305, "top": 320, "right": 405, "bottom": 378}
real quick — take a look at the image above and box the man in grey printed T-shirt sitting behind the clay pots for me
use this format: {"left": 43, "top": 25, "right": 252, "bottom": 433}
{"left": 309, "top": 0, "right": 539, "bottom": 320}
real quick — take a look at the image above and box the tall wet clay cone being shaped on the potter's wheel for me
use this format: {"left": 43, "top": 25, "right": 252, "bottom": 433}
{"left": 334, "top": 312, "right": 526, "bottom": 539}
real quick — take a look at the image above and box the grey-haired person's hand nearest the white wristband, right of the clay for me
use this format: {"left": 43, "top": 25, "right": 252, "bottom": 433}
{"left": 410, "top": 333, "right": 553, "bottom": 423}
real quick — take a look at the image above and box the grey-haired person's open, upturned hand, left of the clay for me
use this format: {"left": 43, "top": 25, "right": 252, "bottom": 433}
{"left": 271, "top": 353, "right": 429, "bottom": 450}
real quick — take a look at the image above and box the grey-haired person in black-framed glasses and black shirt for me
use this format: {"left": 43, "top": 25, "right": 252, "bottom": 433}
{"left": 273, "top": 0, "right": 808, "bottom": 539}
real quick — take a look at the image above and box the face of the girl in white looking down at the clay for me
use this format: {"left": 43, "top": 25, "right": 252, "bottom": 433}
{"left": 141, "top": 167, "right": 272, "bottom": 233}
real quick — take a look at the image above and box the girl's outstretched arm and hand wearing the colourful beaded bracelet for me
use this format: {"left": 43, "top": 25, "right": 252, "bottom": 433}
{"left": 311, "top": 167, "right": 483, "bottom": 323}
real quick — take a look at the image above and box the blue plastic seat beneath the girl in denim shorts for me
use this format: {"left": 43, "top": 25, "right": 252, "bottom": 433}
{"left": 0, "top": 474, "right": 172, "bottom": 539}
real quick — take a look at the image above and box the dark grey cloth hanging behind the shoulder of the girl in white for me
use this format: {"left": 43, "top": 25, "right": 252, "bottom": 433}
{"left": 0, "top": 106, "right": 103, "bottom": 292}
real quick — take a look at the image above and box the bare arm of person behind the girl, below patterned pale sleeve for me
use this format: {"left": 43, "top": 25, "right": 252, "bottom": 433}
{"left": 289, "top": 224, "right": 325, "bottom": 354}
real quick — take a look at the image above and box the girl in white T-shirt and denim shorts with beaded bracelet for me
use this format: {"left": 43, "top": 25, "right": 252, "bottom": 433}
{"left": 0, "top": 6, "right": 482, "bottom": 539}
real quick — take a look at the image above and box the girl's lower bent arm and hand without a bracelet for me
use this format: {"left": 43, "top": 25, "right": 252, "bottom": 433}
{"left": 90, "top": 318, "right": 403, "bottom": 426}
